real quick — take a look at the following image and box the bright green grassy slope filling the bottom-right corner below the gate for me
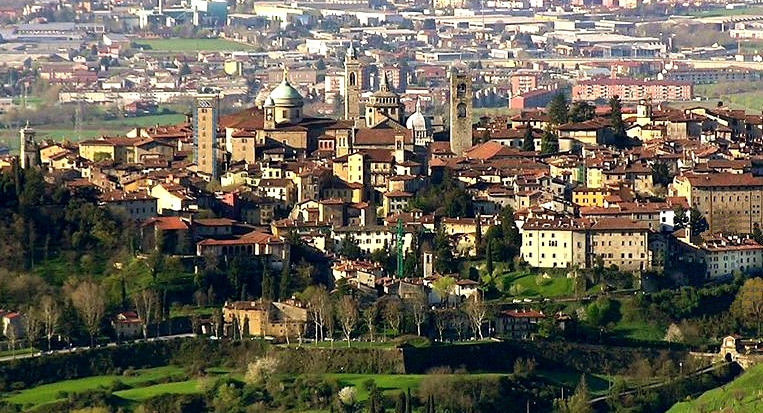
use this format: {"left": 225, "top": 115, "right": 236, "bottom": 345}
{"left": 667, "top": 365, "right": 763, "bottom": 413}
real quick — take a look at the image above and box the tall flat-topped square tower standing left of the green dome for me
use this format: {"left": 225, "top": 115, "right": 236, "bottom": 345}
{"left": 193, "top": 93, "right": 220, "bottom": 179}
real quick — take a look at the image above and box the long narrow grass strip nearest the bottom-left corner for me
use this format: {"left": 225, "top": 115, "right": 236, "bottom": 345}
{"left": 5, "top": 366, "right": 183, "bottom": 406}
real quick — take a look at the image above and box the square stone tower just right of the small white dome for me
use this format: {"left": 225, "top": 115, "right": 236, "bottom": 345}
{"left": 449, "top": 68, "right": 472, "bottom": 156}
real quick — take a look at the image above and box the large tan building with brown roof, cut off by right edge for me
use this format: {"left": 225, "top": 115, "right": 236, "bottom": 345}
{"left": 669, "top": 173, "right": 763, "bottom": 234}
